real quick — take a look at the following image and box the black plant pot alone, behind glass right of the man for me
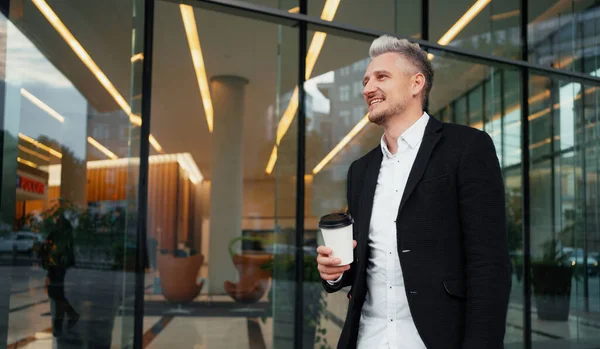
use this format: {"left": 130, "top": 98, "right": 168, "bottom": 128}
{"left": 531, "top": 263, "right": 573, "bottom": 321}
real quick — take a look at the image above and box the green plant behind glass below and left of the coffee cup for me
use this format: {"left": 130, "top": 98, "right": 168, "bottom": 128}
{"left": 263, "top": 250, "right": 331, "bottom": 349}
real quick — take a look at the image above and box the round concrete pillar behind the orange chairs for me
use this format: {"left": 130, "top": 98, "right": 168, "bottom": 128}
{"left": 208, "top": 76, "right": 248, "bottom": 294}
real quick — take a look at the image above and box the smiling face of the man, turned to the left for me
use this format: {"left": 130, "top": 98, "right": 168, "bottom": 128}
{"left": 363, "top": 53, "right": 420, "bottom": 125}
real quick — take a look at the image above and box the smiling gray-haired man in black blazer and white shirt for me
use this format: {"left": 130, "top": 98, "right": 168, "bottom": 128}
{"left": 317, "top": 36, "right": 511, "bottom": 349}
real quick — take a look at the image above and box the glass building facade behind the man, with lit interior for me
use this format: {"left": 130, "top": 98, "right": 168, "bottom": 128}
{"left": 0, "top": 0, "right": 600, "bottom": 349}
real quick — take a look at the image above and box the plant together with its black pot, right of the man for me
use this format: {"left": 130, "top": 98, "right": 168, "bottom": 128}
{"left": 531, "top": 239, "right": 573, "bottom": 321}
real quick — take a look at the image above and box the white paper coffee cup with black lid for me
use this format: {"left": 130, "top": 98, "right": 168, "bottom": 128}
{"left": 319, "top": 213, "right": 354, "bottom": 266}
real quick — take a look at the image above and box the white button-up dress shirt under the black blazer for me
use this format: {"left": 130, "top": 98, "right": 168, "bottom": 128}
{"left": 358, "top": 113, "right": 429, "bottom": 349}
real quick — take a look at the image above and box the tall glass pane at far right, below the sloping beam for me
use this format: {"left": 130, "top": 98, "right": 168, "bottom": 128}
{"left": 529, "top": 72, "right": 600, "bottom": 348}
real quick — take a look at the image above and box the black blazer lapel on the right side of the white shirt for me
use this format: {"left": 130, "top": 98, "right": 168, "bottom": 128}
{"left": 398, "top": 116, "right": 442, "bottom": 217}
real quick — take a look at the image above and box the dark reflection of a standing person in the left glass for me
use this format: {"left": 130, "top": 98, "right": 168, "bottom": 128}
{"left": 40, "top": 214, "right": 79, "bottom": 337}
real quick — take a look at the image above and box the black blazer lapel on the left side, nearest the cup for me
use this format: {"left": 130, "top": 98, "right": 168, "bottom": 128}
{"left": 358, "top": 147, "right": 383, "bottom": 258}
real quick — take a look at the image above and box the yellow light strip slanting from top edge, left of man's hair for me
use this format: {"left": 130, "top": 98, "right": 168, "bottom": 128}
{"left": 265, "top": 0, "right": 340, "bottom": 174}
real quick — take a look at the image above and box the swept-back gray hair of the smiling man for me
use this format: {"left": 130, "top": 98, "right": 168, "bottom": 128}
{"left": 369, "top": 35, "right": 433, "bottom": 105}
